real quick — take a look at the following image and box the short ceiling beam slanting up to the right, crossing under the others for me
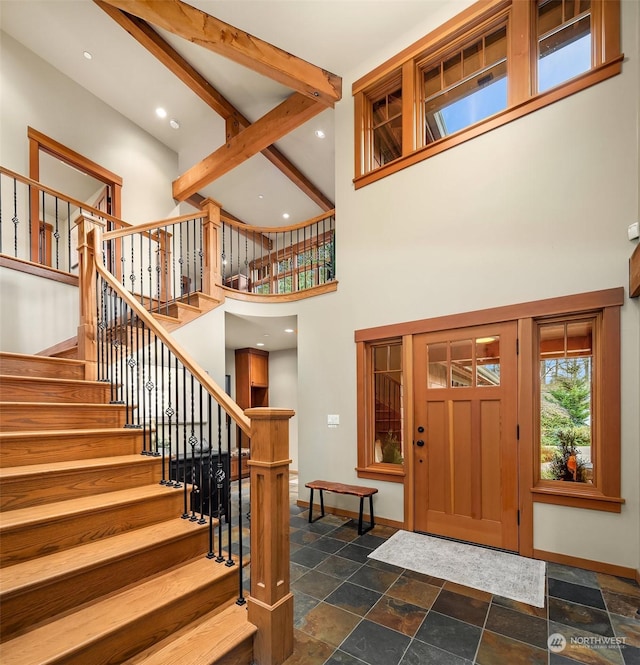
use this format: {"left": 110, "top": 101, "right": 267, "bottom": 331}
{"left": 173, "top": 92, "right": 325, "bottom": 201}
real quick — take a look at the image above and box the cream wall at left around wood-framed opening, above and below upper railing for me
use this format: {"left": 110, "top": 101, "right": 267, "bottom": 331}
{"left": 0, "top": 32, "right": 178, "bottom": 353}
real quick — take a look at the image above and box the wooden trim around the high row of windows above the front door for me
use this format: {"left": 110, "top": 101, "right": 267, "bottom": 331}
{"left": 352, "top": 0, "right": 624, "bottom": 189}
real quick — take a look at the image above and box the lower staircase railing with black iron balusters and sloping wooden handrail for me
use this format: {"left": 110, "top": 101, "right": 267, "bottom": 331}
{"left": 95, "top": 248, "right": 250, "bottom": 604}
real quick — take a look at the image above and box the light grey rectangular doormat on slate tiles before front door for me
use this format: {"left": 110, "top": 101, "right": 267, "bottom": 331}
{"left": 369, "top": 531, "right": 545, "bottom": 607}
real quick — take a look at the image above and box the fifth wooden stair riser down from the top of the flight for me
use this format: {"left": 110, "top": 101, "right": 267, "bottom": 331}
{"left": 0, "top": 458, "right": 162, "bottom": 510}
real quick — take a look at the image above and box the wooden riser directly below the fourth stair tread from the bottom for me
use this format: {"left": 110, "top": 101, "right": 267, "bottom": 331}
{"left": 0, "top": 488, "right": 184, "bottom": 566}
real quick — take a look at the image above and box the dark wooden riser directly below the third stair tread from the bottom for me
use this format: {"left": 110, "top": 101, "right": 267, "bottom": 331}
{"left": 0, "top": 527, "right": 208, "bottom": 641}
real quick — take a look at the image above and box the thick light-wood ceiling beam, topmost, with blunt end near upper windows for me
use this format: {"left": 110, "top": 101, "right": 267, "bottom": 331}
{"left": 96, "top": 0, "right": 342, "bottom": 106}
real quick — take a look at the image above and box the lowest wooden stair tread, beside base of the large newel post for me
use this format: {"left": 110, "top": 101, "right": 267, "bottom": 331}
{"left": 126, "top": 601, "right": 258, "bottom": 665}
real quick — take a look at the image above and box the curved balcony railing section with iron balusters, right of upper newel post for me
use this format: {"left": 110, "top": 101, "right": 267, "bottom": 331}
{"left": 219, "top": 210, "right": 336, "bottom": 295}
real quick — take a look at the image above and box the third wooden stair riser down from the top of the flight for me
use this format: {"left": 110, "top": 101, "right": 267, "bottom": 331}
{"left": 0, "top": 403, "right": 125, "bottom": 432}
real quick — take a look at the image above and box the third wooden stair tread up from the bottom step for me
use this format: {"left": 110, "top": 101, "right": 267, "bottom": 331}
{"left": 0, "top": 517, "right": 208, "bottom": 600}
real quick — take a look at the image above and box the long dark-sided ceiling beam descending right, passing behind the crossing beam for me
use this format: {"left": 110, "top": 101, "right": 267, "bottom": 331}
{"left": 94, "top": 0, "right": 335, "bottom": 212}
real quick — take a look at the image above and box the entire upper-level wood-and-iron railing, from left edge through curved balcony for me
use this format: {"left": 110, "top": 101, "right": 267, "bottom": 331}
{"left": 0, "top": 167, "right": 337, "bottom": 306}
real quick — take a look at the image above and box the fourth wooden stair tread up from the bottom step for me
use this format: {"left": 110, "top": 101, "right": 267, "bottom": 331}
{"left": 0, "top": 484, "right": 183, "bottom": 533}
